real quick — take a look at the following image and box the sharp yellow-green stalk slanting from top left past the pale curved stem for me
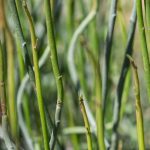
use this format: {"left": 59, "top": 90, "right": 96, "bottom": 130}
{"left": 23, "top": 1, "right": 49, "bottom": 150}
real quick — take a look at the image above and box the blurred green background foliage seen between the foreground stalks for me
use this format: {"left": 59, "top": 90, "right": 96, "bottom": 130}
{"left": 0, "top": 0, "right": 150, "bottom": 150}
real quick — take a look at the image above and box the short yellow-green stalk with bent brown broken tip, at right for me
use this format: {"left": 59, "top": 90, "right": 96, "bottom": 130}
{"left": 128, "top": 55, "right": 145, "bottom": 150}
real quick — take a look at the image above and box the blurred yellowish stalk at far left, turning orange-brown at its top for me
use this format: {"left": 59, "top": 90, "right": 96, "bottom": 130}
{"left": 0, "top": 0, "right": 18, "bottom": 142}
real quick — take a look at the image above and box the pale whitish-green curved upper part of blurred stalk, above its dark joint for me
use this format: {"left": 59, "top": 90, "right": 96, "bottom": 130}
{"left": 67, "top": 0, "right": 97, "bottom": 87}
